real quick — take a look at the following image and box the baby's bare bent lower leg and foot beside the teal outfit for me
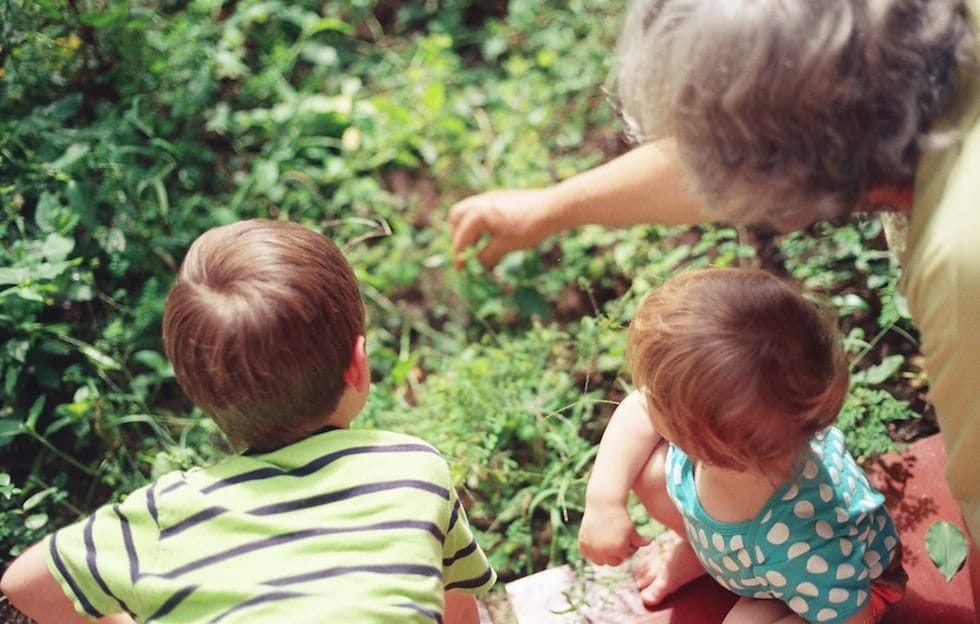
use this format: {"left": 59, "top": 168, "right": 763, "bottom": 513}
{"left": 632, "top": 442, "right": 706, "bottom": 606}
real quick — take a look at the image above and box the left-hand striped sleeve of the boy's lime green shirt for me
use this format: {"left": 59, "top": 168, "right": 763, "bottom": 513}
{"left": 45, "top": 480, "right": 158, "bottom": 618}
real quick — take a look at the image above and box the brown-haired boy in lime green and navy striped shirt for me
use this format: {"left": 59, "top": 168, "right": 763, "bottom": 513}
{"left": 0, "top": 220, "right": 496, "bottom": 624}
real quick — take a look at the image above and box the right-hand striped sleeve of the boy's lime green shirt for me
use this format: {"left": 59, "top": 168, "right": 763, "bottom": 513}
{"left": 442, "top": 488, "right": 497, "bottom": 594}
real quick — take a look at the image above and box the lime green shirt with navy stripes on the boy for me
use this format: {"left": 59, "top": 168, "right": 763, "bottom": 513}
{"left": 46, "top": 429, "right": 496, "bottom": 624}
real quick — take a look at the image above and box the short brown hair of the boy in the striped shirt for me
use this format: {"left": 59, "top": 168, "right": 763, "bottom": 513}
{"left": 163, "top": 219, "right": 365, "bottom": 449}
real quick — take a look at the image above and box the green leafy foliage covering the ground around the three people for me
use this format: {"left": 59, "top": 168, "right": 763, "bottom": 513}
{"left": 0, "top": 0, "right": 928, "bottom": 578}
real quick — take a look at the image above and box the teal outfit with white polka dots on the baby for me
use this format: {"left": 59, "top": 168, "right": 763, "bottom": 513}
{"left": 667, "top": 427, "right": 898, "bottom": 624}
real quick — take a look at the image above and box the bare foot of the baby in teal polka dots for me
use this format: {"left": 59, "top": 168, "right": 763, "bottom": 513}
{"left": 632, "top": 531, "right": 707, "bottom": 607}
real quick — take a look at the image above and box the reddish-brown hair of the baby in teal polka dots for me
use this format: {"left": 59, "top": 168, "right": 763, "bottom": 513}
{"left": 627, "top": 268, "right": 848, "bottom": 471}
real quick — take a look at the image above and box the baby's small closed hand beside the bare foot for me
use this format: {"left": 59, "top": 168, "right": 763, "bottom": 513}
{"left": 578, "top": 503, "right": 650, "bottom": 565}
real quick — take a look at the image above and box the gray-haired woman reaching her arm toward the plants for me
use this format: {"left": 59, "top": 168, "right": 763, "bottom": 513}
{"left": 450, "top": 0, "right": 980, "bottom": 616}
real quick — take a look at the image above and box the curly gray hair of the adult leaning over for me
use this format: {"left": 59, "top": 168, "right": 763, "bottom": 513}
{"left": 617, "top": 0, "right": 977, "bottom": 229}
